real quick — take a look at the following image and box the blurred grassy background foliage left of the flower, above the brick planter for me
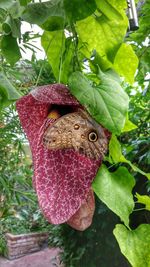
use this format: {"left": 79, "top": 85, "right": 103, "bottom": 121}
{"left": 0, "top": 56, "right": 54, "bottom": 254}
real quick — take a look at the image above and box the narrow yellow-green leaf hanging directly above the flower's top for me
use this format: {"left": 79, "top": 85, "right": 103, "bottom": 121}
{"left": 41, "top": 31, "right": 73, "bottom": 84}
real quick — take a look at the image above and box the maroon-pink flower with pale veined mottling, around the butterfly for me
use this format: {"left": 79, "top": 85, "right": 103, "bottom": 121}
{"left": 17, "top": 84, "right": 101, "bottom": 224}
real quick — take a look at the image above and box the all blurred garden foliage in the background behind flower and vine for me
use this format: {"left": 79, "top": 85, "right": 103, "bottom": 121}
{"left": 0, "top": 0, "right": 150, "bottom": 267}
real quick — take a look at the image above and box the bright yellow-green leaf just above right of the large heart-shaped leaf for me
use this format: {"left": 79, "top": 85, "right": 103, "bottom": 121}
{"left": 113, "top": 43, "right": 139, "bottom": 84}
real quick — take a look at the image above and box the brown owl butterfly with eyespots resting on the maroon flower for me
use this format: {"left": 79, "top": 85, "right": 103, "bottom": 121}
{"left": 43, "top": 109, "right": 108, "bottom": 159}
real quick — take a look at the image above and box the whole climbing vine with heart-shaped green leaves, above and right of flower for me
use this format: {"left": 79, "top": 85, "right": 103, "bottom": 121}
{"left": 0, "top": 0, "right": 150, "bottom": 267}
